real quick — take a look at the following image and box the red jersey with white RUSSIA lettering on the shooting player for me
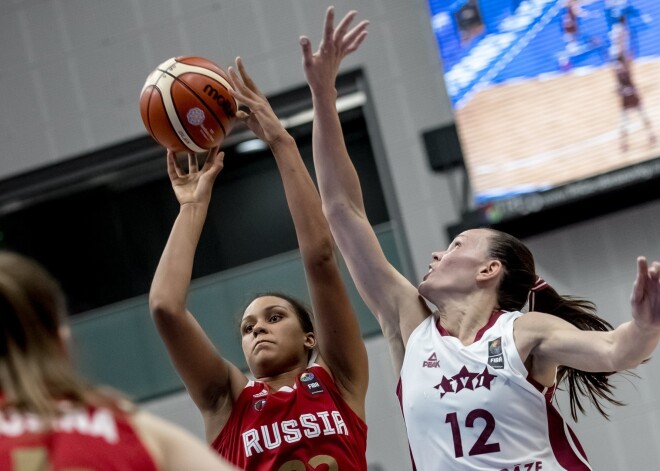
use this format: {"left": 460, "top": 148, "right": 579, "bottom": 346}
{"left": 212, "top": 365, "right": 367, "bottom": 471}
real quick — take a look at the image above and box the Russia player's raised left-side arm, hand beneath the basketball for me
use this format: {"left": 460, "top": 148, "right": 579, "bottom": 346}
{"left": 149, "top": 149, "right": 247, "bottom": 441}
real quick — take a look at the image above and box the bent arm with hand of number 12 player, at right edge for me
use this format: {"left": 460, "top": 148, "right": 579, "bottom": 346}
{"left": 516, "top": 257, "right": 660, "bottom": 380}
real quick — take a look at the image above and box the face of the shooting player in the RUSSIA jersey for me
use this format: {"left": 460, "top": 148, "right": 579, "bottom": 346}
{"left": 241, "top": 296, "right": 314, "bottom": 377}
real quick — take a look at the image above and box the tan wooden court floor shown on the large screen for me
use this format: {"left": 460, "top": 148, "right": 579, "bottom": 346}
{"left": 456, "top": 59, "right": 660, "bottom": 198}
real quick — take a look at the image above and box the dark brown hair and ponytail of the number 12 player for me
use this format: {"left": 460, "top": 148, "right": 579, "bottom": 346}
{"left": 489, "top": 229, "right": 623, "bottom": 420}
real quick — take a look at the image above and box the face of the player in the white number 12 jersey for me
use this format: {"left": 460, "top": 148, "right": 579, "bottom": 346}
{"left": 418, "top": 229, "right": 490, "bottom": 302}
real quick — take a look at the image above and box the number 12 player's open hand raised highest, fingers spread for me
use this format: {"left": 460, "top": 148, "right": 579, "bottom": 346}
{"left": 300, "top": 7, "right": 369, "bottom": 93}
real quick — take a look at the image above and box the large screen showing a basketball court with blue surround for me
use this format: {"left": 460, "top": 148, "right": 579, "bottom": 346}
{"left": 429, "top": 0, "right": 660, "bottom": 206}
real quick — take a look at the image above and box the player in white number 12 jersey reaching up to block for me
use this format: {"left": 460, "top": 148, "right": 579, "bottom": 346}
{"left": 300, "top": 8, "right": 660, "bottom": 471}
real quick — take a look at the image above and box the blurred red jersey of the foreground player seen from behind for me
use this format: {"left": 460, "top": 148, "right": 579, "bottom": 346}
{"left": 0, "top": 407, "right": 157, "bottom": 471}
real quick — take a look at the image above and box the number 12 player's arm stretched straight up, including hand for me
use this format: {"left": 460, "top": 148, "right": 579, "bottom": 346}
{"left": 300, "top": 7, "right": 429, "bottom": 365}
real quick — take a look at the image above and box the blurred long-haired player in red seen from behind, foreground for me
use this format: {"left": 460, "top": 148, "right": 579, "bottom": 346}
{"left": 0, "top": 251, "right": 235, "bottom": 471}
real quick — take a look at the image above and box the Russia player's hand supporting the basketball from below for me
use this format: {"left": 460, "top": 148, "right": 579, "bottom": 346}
{"left": 167, "top": 147, "right": 225, "bottom": 205}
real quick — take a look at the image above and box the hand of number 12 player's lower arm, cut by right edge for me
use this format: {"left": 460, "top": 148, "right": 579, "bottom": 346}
{"left": 630, "top": 257, "right": 660, "bottom": 329}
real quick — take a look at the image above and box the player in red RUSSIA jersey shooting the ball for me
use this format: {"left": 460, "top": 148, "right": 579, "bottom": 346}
{"left": 150, "top": 14, "right": 368, "bottom": 471}
